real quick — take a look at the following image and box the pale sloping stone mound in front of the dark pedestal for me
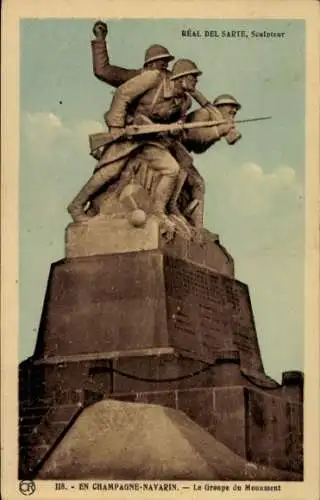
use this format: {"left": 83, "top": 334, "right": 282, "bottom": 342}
{"left": 37, "top": 400, "right": 302, "bottom": 481}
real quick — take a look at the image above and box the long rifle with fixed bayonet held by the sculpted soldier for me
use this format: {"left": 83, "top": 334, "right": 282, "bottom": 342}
{"left": 89, "top": 116, "right": 271, "bottom": 154}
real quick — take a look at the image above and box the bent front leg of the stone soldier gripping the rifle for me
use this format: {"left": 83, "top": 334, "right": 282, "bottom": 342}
{"left": 141, "top": 145, "right": 180, "bottom": 215}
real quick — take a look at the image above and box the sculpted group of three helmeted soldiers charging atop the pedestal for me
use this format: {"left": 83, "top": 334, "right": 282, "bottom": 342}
{"left": 68, "top": 21, "right": 241, "bottom": 238}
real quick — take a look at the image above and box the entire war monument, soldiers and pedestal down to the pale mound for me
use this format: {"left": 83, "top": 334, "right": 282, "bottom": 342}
{"left": 19, "top": 21, "right": 303, "bottom": 481}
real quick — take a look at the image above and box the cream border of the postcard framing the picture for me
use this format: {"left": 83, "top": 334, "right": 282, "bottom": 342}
{"left": 1, "top": 0, "right": 319, "bottom": 500}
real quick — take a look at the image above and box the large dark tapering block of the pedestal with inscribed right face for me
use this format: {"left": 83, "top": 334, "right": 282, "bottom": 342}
{"left": 35, "top": 250, "right": 264, "bottom": 382}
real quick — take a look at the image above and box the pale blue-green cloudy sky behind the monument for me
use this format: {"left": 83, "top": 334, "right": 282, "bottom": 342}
{"left": 20, "top": 19, "right": 305, "bottom": 381}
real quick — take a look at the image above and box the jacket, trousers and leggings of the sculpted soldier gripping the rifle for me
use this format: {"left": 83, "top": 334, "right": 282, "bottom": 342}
{"left": 68, "top": 65, "right": 195, "bottom": 220}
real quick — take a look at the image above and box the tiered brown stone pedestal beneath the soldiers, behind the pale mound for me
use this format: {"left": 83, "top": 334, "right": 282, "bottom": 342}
{"left": 20, "top": 219, "right": 303, "bottom": 479}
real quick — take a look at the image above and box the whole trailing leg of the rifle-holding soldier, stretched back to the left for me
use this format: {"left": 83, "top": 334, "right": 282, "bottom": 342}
{"left": 67, "top": 159, "right": 124, "bottom": 222}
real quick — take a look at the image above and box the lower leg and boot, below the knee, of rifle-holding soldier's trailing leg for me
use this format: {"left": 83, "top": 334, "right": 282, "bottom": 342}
{"left": 67, "top": 171, "right": 106, "bottom": 222}
